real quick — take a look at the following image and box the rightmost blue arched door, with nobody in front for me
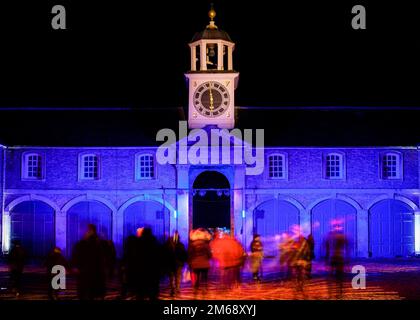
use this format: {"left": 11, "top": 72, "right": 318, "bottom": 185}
{"left": 369, "top": 199, "right": 414, "bottom": 257}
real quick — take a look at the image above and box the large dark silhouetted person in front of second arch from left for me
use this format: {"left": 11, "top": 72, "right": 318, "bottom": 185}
{"left": 72, "top": 224, "right": 106, "bottom": 300}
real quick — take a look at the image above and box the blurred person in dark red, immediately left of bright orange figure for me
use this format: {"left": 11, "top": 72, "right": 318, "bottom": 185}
{"left": 188, "top": 228, "right": 212, "bottom": 294}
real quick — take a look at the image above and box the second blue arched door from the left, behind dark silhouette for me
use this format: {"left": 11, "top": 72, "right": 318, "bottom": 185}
{"left": 67, "top": 201, "right": 112, "bottom": 255}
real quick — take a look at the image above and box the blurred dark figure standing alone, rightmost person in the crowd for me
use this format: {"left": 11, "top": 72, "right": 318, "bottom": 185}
{"left": 325, "top": 225, "right": 349, "bottom": 299}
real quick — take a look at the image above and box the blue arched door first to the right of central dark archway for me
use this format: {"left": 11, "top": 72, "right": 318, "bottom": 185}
{"left": 253, "top": 199, "right": 299, "bottom": 255}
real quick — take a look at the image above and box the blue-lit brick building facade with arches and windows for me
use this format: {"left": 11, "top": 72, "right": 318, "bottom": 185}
{"left": 0, "top": 147, "right": 420, "bottom": 257}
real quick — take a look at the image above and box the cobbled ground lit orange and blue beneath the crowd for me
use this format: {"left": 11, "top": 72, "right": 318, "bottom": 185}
{"left": 0, "top": 259, "right": 420, "bottom": 300}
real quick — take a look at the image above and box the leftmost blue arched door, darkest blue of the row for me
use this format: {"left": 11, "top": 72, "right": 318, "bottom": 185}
{"left": 10, "top": 200, "right": 55, "bottom": 258}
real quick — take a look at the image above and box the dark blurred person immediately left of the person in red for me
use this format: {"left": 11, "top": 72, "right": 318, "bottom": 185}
{"left": 164, "top": 231, "right": 188, "bottom": 296}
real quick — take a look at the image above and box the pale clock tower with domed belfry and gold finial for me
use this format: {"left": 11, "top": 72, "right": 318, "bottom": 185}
{"left": 185, "top": 7, "right": 239, "bottom": 129}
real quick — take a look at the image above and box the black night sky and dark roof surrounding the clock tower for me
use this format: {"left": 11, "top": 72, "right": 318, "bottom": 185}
{"left": 0, "top": 0, "right": 420, "bottom": 145}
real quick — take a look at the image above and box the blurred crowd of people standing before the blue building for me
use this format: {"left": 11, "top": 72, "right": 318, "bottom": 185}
{"left": 4, "top": 224, "right": 349, "bottom": 300}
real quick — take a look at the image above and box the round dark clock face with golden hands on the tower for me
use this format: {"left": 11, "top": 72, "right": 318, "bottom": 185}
{"left": 193, "top": 81, "right": 230, "bottom": 118}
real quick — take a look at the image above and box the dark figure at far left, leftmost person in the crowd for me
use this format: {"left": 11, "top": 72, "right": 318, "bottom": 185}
{"left": 8, "top": 240, "right": 26, "bottom": 297}
